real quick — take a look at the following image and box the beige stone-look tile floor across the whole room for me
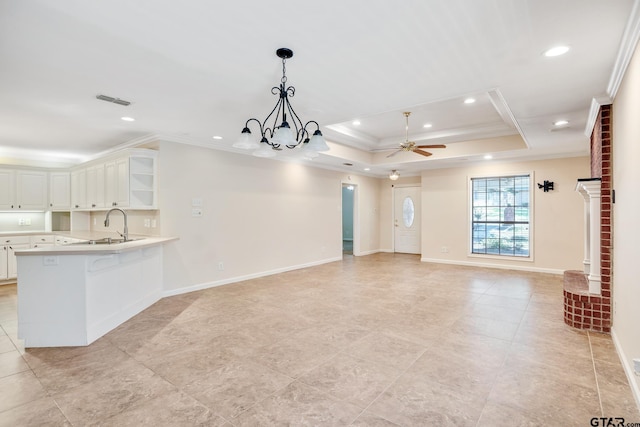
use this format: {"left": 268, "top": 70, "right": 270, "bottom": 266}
{"left": 0, "top": 254, "right": 640, "bottom": 426}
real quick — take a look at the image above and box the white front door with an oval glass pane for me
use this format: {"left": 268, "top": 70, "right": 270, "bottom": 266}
{"left": 393, "top": 187, "right": 421, "bottom": 254}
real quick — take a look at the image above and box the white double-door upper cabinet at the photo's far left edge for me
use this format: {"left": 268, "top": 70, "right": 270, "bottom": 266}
{"left": 0, "top": 169, "right": 48, "bottom": 211}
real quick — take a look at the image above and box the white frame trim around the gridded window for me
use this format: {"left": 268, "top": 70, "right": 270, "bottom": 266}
{"left": 467, "top": 171, "right": 535, "bottom": 262}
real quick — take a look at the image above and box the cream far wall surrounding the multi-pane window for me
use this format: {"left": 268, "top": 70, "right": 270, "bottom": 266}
{"left": 422, "top": 157, "right": 590, "bottom": 273}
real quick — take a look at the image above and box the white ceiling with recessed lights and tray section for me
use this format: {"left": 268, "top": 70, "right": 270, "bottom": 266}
{"left": 0, "top": 0, "right": 638, "bottom": 176}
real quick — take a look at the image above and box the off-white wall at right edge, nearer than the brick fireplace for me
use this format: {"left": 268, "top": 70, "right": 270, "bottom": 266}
{"left": 612, "top": 40, "right": 640, "bottom": 405}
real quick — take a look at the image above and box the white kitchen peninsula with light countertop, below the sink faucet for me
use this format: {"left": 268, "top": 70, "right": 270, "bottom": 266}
{"left": 16, "top": 237, "right": 177, "bottom": 347}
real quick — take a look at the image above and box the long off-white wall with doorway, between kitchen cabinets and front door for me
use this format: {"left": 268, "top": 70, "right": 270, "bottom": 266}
{"left": 159, "top": 142, "right": 379, "bottom": 293}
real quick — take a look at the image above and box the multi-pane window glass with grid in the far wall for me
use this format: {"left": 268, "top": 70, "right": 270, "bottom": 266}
{"left": 471, "top": 174, "right": 531, "bottom": 257}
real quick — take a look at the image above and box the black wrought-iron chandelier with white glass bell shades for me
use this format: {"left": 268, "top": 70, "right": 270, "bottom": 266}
{"left": 233, "top": 47, "right": 329, "bottom": 159}
